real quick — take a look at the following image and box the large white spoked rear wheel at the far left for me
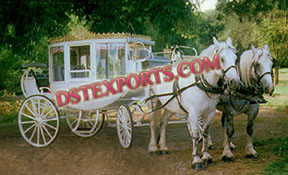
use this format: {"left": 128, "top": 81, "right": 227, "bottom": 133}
{"left": 18, "top": 96, "right": 59, "bottom": 147}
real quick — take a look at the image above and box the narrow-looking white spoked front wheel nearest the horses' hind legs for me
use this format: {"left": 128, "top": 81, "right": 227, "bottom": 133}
{"left": 117, "top": 106, "right": 133, "bottom": 148}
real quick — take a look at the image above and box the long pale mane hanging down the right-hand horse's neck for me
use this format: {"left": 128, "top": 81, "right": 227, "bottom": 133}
{"left": 239, "top": 48, "right": 263, "bottom": 86}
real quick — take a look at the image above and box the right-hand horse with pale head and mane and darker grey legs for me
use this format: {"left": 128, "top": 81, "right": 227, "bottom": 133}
{"left": 208, "top": 44, "right": 274, "bottom": 161}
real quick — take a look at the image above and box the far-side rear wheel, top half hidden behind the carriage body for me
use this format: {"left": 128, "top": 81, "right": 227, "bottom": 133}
{"left": 66, "top": 110, "right": 104, "bottom": 137}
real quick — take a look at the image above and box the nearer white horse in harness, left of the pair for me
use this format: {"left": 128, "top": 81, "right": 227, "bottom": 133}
{"left": 148, "top": 37, "right": 240, "bottom": 169}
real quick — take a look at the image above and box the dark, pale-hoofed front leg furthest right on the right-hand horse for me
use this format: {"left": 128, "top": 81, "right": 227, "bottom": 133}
{"left": 246, "top": 105, "right": 259, "bottom": 158}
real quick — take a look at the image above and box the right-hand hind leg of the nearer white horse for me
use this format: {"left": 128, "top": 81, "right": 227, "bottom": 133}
{"left": 158, "top": 109, "right": 172, "bottom": 154}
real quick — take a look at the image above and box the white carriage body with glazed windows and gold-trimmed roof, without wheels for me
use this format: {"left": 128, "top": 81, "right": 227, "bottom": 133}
{"left": 22, "top": 33, "right": 169, "bottom": 110}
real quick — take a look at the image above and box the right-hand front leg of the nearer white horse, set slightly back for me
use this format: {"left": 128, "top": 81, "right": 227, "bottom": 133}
{"left": 201, "top": 112, "right": 215, "bottom": 165}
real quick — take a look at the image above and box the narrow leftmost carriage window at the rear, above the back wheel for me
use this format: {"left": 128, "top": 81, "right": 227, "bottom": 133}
{"left": 50, "top": 46, "right": 65, "bottom": 81}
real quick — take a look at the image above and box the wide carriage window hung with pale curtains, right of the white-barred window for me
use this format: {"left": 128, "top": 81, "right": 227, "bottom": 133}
{"left": 96, "top": 43, "right": 125, "bottom": 79}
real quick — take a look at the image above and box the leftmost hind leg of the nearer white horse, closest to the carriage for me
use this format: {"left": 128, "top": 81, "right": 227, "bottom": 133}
{"left": 148, "top": 100, "right": 160, "bottom": 154}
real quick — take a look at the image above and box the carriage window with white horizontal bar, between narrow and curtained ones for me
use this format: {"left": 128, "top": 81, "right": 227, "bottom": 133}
{"left": 70, "top": 46, "right": 90, "bottom": 78}
